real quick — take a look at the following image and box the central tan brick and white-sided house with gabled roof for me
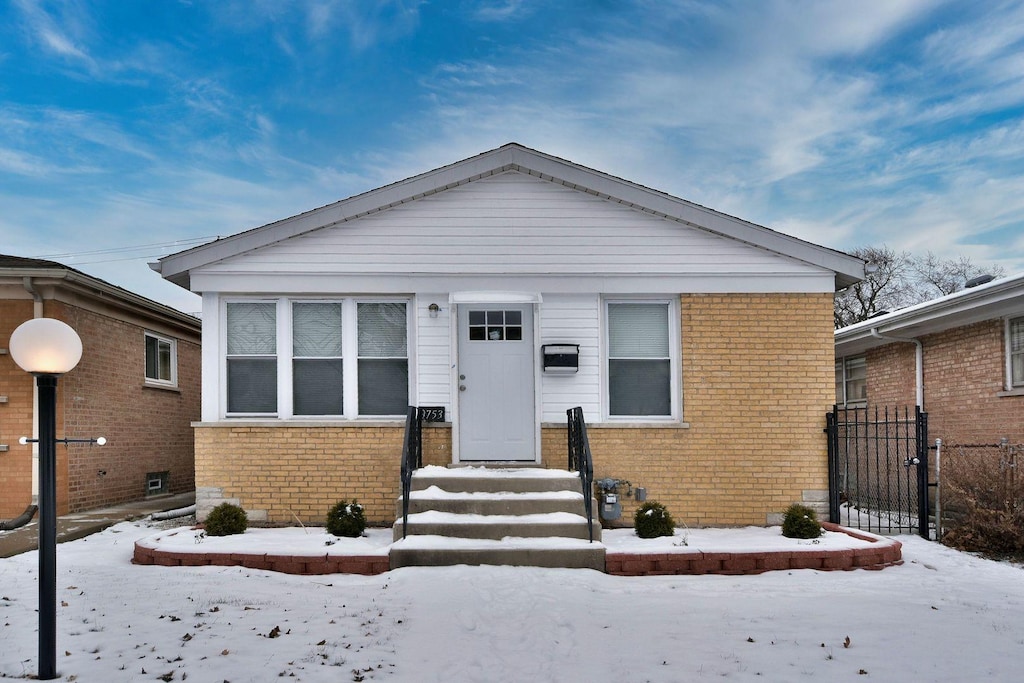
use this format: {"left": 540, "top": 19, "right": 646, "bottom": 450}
{"left": 153, "top": 143, "right": 864, "bottom": 525}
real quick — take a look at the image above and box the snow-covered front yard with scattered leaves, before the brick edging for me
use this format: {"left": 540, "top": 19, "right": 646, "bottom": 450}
{"left": 0, "top": 521, "right": 1024, "bottom": 683}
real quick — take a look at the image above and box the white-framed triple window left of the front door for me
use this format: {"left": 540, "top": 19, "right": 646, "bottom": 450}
{"left": 225, "top": 298, "right": 409, "bottom": 418}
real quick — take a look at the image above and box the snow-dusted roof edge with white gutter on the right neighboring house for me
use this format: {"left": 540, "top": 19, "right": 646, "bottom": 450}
{"left": 836, "top": 273, "right": 1024, "bottom": 355}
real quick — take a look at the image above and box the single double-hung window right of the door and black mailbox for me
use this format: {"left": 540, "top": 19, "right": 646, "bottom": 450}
{"left": 605, "top": 301, "right": 679, "bottom": 419}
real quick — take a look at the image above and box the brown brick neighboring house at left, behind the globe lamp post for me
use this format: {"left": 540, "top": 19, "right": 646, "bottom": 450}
{"left": 0, "top": 256, "right": 202, "bottom": 519}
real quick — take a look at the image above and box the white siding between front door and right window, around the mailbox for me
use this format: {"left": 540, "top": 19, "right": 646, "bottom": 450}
{"left": 538, "top": 295, "right": 601, "bottom": 424}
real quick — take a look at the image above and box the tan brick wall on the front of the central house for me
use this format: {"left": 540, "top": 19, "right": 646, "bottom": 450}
{"left": 196, "top": 294, "right": 834, "bottom": 525}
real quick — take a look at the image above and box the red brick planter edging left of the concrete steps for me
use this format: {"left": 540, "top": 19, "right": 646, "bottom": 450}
{"left": 132, "top": 542, "right": 391, "bottom": 575}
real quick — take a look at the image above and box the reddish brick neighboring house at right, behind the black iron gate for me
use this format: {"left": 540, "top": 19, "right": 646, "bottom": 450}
{"left": 835, "top": 274, "right": 1024, "bottom": 443}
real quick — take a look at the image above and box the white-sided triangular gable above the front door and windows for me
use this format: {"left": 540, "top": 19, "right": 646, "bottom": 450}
{"left": 191, "top": 171, "right": 835, "bottom": 293}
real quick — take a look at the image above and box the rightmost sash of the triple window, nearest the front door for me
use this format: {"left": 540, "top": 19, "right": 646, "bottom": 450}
{"left": 357, "top": 303, "right": 409, "bottom": 415}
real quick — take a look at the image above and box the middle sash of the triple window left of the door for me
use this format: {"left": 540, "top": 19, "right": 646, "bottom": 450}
{"left": 292, "top": 303, "right": 344, "bottom": 415}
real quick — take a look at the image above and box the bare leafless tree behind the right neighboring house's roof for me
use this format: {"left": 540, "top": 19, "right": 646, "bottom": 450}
{"left": 834, "top": 245, "right": 1005, "bottom": 329}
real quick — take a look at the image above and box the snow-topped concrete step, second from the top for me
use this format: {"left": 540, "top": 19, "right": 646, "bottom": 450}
{"left": 395, "top": 486, "right": 584, "bottom": 517}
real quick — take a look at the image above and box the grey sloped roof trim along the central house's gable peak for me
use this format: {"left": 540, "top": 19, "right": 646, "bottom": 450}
{"left": 151, "top": 143, "right": 864, "bottom": 289}
